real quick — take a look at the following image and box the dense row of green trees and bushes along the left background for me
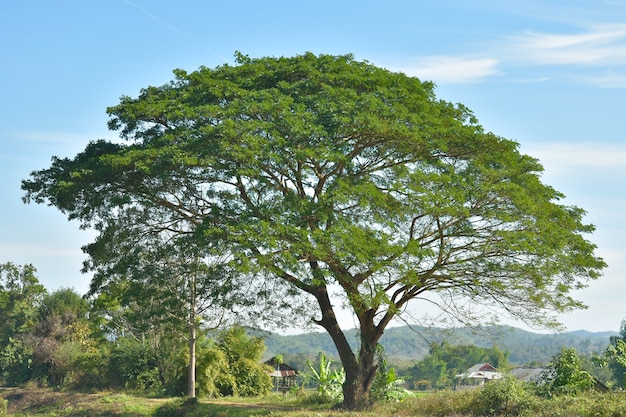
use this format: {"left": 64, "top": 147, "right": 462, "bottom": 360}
{"left": 0, "top": 263, "right": 272, "bottom": 397}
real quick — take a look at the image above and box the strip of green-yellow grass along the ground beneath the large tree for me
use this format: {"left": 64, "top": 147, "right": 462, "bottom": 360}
{"left": 0, "top": 388, "right": 626, "bottom": 417}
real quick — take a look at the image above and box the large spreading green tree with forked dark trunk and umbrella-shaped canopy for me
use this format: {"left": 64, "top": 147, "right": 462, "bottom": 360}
{"left": 22, "top": 54, "right": 604, "bottom": 408}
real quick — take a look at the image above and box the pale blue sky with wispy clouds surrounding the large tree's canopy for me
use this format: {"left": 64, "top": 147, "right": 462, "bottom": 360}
{"left": 0, "top": 0, "right": 626, "bottom": 331}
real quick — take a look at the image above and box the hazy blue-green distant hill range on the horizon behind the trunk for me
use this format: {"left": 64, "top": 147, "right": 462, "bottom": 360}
{"left": 254, "top": 326, "right": 618, "bottom": 365}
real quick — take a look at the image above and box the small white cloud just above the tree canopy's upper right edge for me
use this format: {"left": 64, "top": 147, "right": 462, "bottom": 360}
{"left": 396, "top": 55, "right": 498, "bottom": 83}
